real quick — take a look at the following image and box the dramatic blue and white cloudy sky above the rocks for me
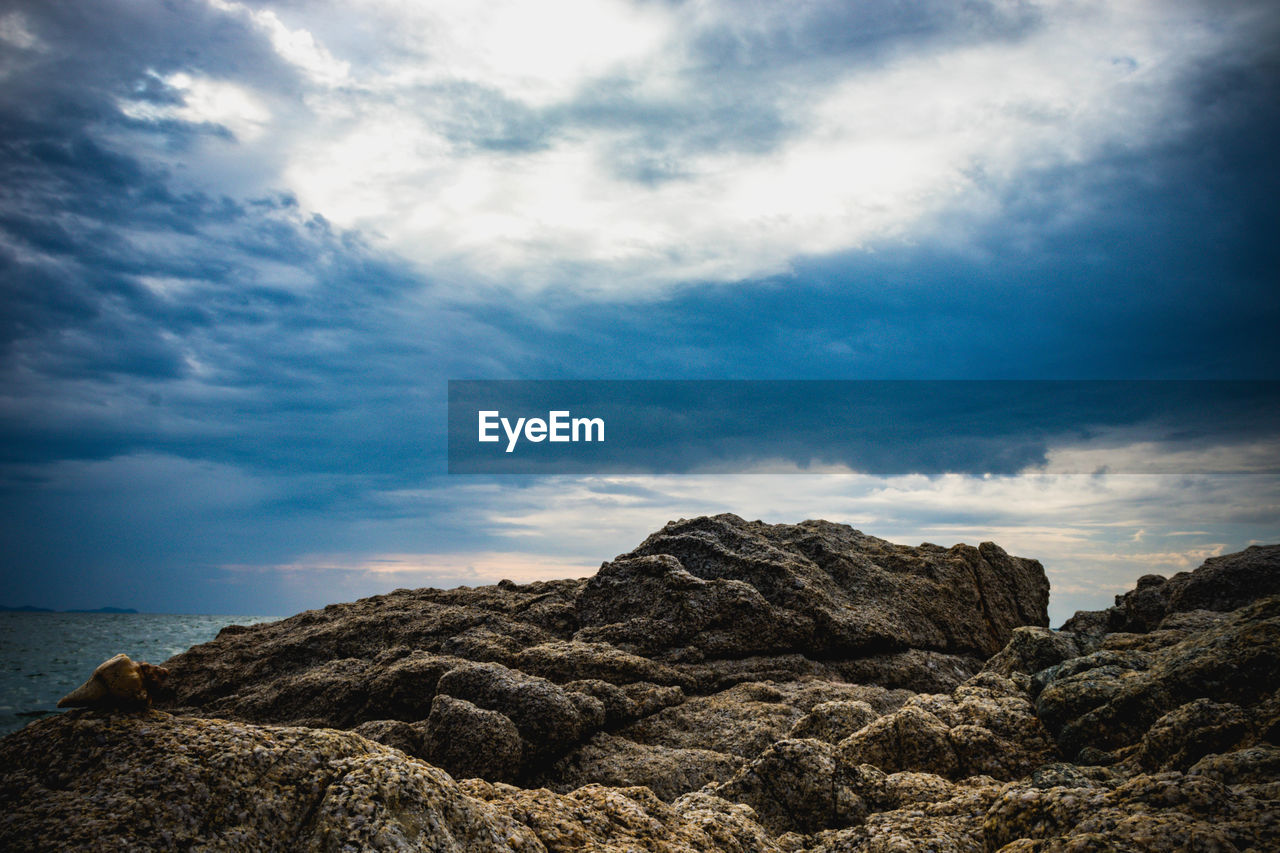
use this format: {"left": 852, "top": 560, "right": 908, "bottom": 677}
{"left": 0, "top": 0, "right": 1280, "bottom": 624}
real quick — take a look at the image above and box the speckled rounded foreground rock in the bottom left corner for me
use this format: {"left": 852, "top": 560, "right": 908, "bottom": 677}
{"left": 0, "top": 711, "right": 535, "bottom": 853}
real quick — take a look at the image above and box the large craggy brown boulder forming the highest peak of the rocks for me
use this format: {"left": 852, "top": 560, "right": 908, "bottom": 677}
{"left": 577, "top": 515, "right": 1048, "bottom": 660}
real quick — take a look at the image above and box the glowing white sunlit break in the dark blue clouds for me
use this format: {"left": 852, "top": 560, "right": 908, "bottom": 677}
{"left": 154, "top": 0, "right": 1233, "bottom": 296}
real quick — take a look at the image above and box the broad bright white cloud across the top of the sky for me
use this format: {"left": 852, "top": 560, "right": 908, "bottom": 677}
{"left": 6, "top": 0, "right": 1275, "bottom": 300}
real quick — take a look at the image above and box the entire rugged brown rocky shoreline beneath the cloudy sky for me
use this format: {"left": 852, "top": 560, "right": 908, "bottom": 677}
{"left": 0, "top": 515, "right": 1280, "bottom": 853}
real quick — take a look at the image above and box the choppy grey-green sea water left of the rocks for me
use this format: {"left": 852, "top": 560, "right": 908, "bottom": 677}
{"left": 0, "top": 612, "right": 279, "bottom": 735}
